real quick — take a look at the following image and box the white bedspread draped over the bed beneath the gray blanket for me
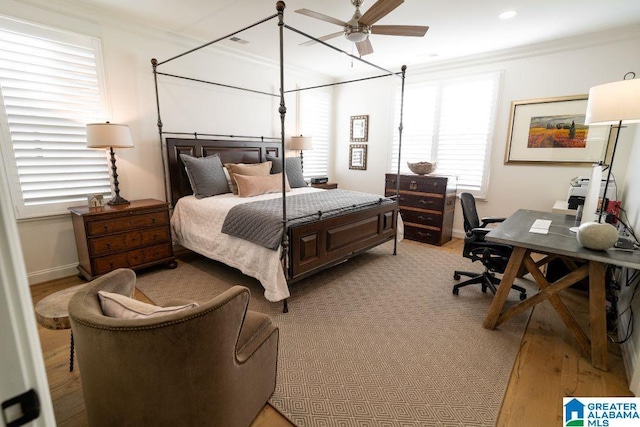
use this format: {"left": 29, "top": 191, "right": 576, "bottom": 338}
{"left": 171, "top": 187, "right": 404, "bottom": 302}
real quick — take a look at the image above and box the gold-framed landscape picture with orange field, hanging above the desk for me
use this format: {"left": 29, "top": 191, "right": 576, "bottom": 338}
{"left": 504, "top": 95, "right": 610, "bottom": 165}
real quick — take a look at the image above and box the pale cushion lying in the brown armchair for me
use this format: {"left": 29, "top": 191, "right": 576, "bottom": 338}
{"left": 98, "top": 291, "right": 198, "bottom": 319}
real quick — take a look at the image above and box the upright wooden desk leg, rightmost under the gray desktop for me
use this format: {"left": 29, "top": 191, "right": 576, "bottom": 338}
{"left": 589, "top": 261, "right": 607, "bottom": 371}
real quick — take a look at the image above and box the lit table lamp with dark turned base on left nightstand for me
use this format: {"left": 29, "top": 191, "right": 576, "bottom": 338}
{"left": 87, "top": 122, "right": 133, "bottom": 206}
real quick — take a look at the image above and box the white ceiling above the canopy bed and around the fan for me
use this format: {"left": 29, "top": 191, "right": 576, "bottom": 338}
{"left": 62, "top": 0, "right": 640, "bottom": 75}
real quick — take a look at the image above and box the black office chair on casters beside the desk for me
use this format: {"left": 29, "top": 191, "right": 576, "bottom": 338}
{"left": 453, "top": 193, "right": 527, "bottom": 300}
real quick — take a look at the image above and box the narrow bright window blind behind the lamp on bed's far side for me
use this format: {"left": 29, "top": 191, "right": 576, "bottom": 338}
{"left": 299, "top": 89, "right": 331, "bottom": 178}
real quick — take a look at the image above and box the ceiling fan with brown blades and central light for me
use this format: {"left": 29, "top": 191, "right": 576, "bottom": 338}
{"left": 296, "top": 0, "right": 429, "bottom": 56}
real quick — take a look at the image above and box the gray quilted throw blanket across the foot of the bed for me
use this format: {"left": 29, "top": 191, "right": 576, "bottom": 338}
{"left": 222, "top": 189, "right": 394, "bottom": 250}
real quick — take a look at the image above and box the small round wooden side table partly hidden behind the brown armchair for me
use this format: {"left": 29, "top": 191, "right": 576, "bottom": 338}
{"left": 35, "top": 283, "right": 87, "bottom": 372}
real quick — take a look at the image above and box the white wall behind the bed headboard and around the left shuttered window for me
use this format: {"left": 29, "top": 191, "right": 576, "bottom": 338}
{"left": 0, "top": 0, "right": 327, "bottom": 283}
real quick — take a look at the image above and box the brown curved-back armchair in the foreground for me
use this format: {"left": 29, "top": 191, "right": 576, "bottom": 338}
{"left": 69, "top": 269, "right": 278, "bottom": 426}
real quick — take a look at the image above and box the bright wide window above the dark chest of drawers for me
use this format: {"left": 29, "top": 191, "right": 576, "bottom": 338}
{"left": 390, "top": 72, "right": 500, "bottom": 197}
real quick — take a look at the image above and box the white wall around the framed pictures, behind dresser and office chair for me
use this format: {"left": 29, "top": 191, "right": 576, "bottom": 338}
{"left": 331, "top": 26, "right": 640, "bottom": 236}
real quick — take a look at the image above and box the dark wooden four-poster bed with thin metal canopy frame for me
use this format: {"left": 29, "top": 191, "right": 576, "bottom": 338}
{"left": 152, "top": 1, "right": 406, "bottom": 312}
